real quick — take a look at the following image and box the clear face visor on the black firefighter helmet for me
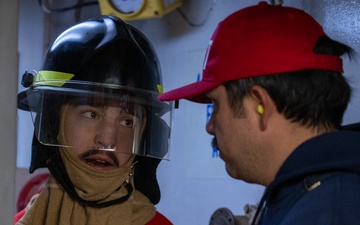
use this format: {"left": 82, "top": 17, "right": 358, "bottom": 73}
{"left": 27, "top": 81, "right": 173, "bottom": 159}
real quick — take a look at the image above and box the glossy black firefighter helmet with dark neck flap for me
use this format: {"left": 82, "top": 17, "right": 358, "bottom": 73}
{"left": 18, "top": 16, "right": 172, "bottom": 206}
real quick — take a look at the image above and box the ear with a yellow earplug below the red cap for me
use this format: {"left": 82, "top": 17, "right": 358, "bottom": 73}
{"left": 250, "top": 85, "right": 277, "bottom": 130}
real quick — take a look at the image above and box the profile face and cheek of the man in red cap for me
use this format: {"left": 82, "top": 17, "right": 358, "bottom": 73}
{"left": 206, "top": 85, "right": 262, "bottom": 183}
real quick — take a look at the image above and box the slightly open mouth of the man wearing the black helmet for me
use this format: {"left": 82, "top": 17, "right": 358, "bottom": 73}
{"left": 81, "top": 150, "right": 118, "bottom": 170}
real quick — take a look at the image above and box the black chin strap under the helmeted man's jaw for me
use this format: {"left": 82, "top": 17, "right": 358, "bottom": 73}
{"left": 46, "top": 150, "right": 134, "bottom": 208}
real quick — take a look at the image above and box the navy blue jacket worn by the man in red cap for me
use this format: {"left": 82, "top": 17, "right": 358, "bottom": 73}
{"left": 259, "top": 127, "right": 360, "bottom": 225}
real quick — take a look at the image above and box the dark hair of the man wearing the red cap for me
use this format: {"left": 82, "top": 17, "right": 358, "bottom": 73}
{"left": 223, "top": 36, "right": 353, "bottom": 128}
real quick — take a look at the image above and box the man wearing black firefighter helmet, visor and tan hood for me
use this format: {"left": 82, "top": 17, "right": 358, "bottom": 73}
{"left": 15, "top": 16, "right": 172, "bottom": 225}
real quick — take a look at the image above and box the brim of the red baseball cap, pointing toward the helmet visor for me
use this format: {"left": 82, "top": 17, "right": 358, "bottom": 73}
{"left": 158, "top": 80, "right": 220, "bottom": 103}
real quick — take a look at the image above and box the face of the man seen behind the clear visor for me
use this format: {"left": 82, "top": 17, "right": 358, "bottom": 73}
{"left": 60, "top": 99, "right": 135, "bottom": 170}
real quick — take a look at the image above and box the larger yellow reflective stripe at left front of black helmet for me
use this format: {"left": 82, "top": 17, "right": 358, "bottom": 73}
{"left": 36, "top": 70, "right": 74, "bottom": 87}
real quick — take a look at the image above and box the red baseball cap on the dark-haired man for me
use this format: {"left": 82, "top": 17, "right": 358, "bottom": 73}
{"left": 158, "top": 2, "right": 343, "bottom": 103}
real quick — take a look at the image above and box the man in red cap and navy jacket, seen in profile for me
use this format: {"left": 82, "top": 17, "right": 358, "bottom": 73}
{"left": 159, "top": 2, "right": 360, "bottom": 225}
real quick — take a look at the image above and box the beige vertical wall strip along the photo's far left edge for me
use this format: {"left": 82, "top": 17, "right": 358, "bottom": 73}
{"left": 0, "top": 0, "right": 18, "bottom": 224}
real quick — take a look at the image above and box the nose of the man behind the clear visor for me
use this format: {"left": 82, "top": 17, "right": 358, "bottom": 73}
{"left": 95, "top": 123, "right": 116, "bottom": 149}
